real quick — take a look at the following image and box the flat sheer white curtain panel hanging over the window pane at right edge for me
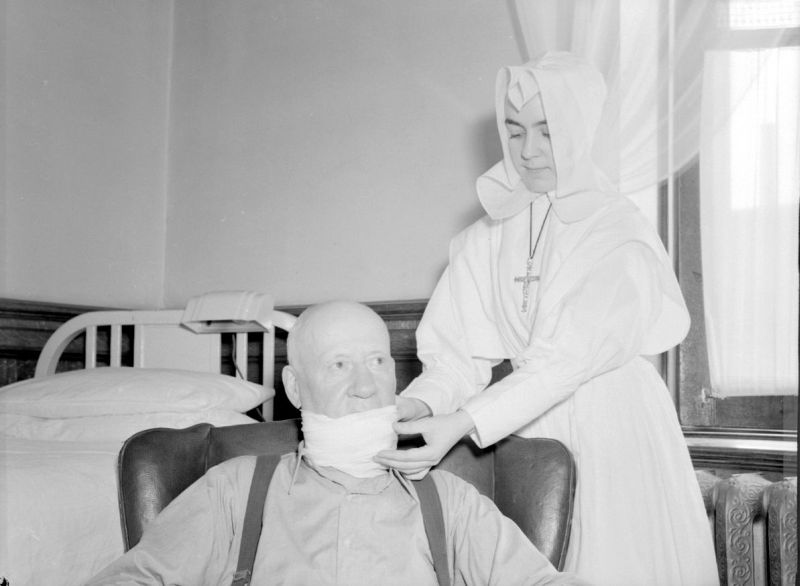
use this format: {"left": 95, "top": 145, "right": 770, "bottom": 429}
{"left": 700, "top": 47, "right": 800, "bottom": 397}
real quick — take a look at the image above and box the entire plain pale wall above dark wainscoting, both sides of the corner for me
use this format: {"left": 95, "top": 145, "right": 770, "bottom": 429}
{"left": 0, "top": 0, "right": 519, "bottom": 307}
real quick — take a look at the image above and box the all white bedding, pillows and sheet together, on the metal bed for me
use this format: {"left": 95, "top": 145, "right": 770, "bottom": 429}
{"left": 0, "top": 368, "right": 273, "bottom": 586}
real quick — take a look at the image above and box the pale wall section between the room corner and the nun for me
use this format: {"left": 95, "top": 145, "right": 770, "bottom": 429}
{"left": 166, "top": 0, "right": 519, "bottom": 305}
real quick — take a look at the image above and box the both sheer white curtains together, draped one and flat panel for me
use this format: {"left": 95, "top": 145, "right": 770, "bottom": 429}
{"left": 512, "top": 0, "right": 800, "bottom": 396}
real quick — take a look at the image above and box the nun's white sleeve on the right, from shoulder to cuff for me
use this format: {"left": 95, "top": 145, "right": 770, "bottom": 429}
{"left": 463, "top": 242, "right": 662, "bottom": 447}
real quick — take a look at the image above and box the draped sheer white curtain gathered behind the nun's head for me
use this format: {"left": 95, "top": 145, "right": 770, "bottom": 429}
{"left": 514, "top": 0, "right": 717, "bottom": 193}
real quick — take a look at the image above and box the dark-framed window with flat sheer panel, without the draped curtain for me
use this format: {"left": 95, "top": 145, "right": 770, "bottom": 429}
{"left": 674, "top": 0, "right": 800, "bottom": 474}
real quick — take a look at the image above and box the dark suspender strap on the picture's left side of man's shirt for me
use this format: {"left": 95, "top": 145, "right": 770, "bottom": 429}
{"left": 231, "top": 454, "right": 280, "bottom": 586}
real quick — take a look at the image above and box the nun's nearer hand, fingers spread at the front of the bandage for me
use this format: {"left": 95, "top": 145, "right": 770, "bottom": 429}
{"left": 375, "top": 410, "right": 475, "bottom": 480}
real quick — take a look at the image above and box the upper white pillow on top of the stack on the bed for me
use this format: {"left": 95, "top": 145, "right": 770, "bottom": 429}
{"left": 0, "top": 367, "right": 275, "bottom": 419}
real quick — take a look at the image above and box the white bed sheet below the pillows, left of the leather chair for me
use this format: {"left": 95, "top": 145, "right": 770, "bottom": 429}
{"left": 0, "top": 436, "right": 123, "bottom": 586}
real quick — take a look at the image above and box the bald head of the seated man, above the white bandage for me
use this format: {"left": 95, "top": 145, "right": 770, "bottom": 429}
{"left": 283, "top": 301, "right": 396, "bottom": 417}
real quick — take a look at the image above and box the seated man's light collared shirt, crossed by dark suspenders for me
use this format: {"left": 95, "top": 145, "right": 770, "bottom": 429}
{"left": 89, "top": 444, "right": 558, "bottom": 585}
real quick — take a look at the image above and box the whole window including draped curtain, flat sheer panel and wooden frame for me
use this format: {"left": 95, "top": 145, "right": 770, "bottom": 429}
{"left": 510, "top": 0, "right": 800, "bottom": 469}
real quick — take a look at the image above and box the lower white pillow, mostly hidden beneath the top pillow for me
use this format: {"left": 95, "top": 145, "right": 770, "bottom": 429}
{"left": 0, "top": 411, "right": 256, "bottom": 443}
